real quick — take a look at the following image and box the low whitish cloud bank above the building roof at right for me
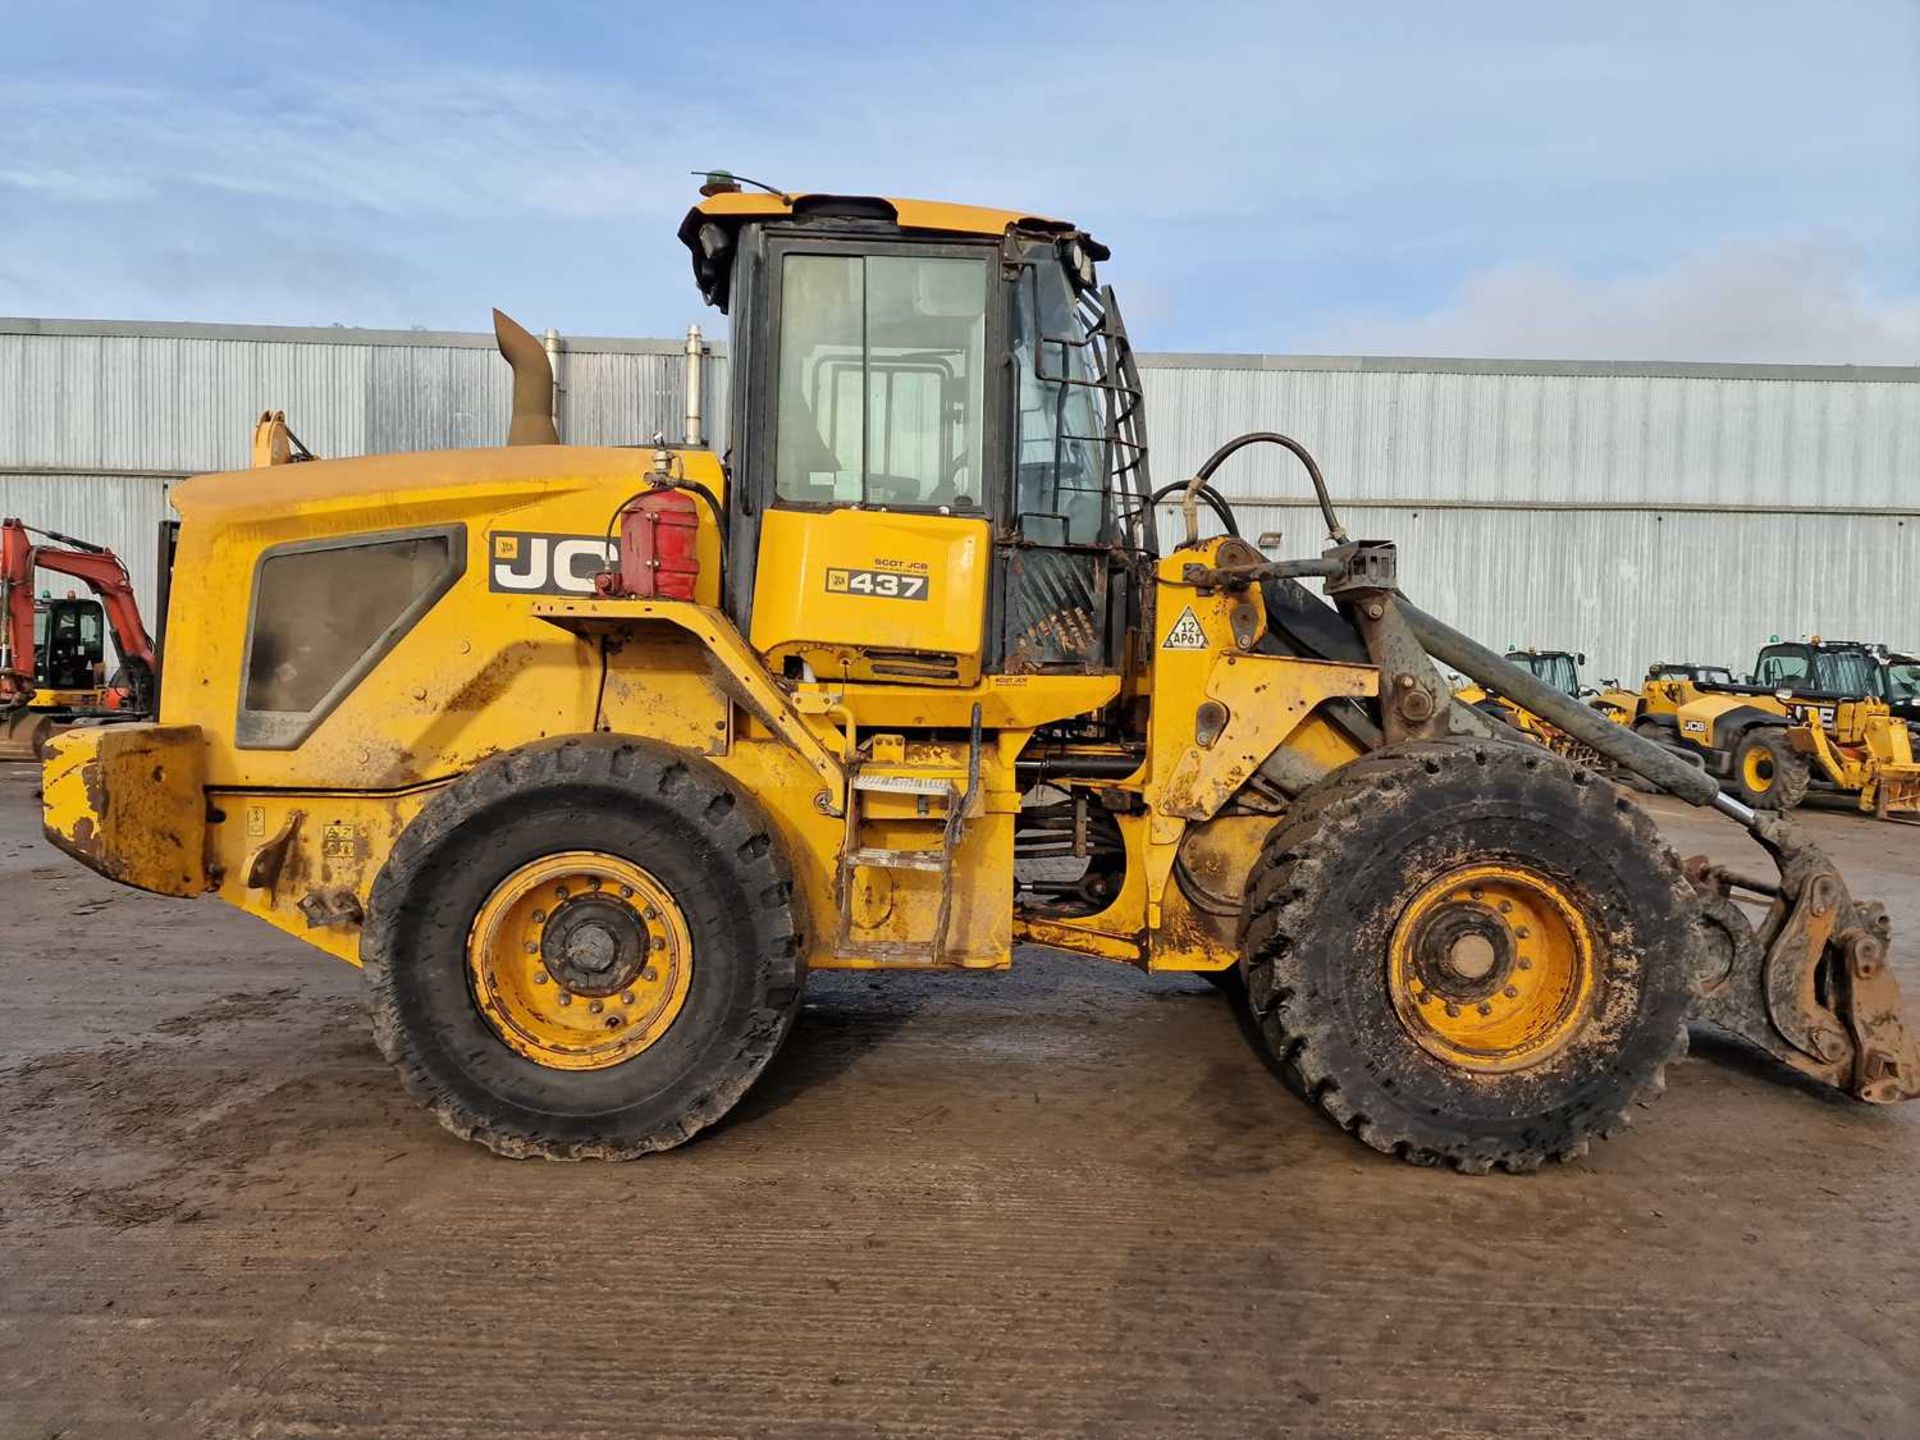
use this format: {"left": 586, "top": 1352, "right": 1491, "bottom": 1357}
{"left": 1292, "top": 236, "right": 1920, "bottom": 365}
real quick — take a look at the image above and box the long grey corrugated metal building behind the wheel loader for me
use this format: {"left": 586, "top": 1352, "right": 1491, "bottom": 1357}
{"left": 0, "top": 319, "right": 1920, "bottom": 680}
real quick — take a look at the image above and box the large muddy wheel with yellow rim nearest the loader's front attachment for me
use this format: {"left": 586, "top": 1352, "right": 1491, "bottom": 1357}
{"left": 1242, "top": 741, "right": 1693, "bottom": 1171}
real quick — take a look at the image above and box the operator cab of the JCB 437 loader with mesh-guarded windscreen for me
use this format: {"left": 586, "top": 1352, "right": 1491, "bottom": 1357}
{"left": 680, "top": 177, "right": 1156, "bottom": 685}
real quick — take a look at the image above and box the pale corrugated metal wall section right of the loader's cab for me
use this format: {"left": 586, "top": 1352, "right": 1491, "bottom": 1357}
{"left": 1142, "top": 355, "right": 1920, "bottom": 680}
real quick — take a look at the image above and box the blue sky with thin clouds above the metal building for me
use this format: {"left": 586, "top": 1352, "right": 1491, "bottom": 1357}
{"left": 0, "top": 0, "right": 1920, "bottom": 365}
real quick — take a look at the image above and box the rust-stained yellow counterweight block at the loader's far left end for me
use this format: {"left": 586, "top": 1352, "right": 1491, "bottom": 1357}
{"left": 40, "top": 726, "right": 207, "bottom": 895}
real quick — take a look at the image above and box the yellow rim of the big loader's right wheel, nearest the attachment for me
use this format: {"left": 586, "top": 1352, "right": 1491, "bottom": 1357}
{"left": 1386, "top": 864, "right": 1597, "bottom": 1073}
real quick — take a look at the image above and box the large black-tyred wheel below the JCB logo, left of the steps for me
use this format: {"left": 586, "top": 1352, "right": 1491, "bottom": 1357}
{"left": 361, "top": 735, "right": 803, "bottom": 1160}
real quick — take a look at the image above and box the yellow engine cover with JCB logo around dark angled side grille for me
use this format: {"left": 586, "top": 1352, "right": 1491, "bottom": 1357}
{"left": 161, "top": 445, "right": 726, "bottom": 791}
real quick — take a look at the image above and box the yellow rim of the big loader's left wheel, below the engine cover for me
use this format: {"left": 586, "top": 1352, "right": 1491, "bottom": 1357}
{"left": 467, "top": 851, "right": 693, "bottom": 1069}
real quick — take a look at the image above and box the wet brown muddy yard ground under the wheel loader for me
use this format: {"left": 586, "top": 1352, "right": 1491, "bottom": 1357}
{"left": 0, "top": 768, "right": 1920, "bottom": 1440}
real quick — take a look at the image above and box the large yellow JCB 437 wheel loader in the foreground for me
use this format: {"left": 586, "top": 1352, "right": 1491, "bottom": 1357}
{"left": 30, "top": 179, "right": 1920, "bottom": 1171}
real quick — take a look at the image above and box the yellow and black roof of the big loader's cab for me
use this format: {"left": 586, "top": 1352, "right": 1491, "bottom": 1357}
{"left": 680, "top": 190, "right": 1108, "bottom": 311}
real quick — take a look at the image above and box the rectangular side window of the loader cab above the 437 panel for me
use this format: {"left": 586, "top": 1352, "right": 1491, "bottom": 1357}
{"left": 774, "top": 253, "right": 989, "bottom": 509}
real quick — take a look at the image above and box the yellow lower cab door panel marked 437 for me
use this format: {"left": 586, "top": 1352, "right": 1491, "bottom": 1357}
{"left": 753, "top": 509, "right": 993, "bottom": 685}
